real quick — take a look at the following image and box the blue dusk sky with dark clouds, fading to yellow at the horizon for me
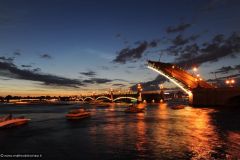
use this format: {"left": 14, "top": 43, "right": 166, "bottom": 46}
{"left": 0, "top": 0, "right": 240, "bottom": 96}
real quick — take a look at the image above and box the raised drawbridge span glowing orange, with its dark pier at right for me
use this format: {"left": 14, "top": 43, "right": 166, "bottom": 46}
{"left": 148, "top": 61, "right": 240, "bottom": 107}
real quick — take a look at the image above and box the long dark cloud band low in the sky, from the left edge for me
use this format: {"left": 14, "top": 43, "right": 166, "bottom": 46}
{"left": 0, "top": 61, "right": 83, "bottom": 88}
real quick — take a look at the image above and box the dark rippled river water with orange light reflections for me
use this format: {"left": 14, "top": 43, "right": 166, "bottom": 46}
{"left": 0, "top": 104, "right": 240, "bottom": 160}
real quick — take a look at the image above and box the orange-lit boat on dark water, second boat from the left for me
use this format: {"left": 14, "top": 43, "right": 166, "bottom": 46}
{"left": 66, "top": 108, "right": 91, "bottom": 120}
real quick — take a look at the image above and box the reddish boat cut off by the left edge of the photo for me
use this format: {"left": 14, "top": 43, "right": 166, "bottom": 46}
{"left": 0, "top": 114, "right": 31, "bottom": 128}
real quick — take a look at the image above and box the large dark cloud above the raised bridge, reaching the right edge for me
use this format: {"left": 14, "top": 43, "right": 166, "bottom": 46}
{"left": 176, "top": 32, "right": 240, "bottom": 65}
